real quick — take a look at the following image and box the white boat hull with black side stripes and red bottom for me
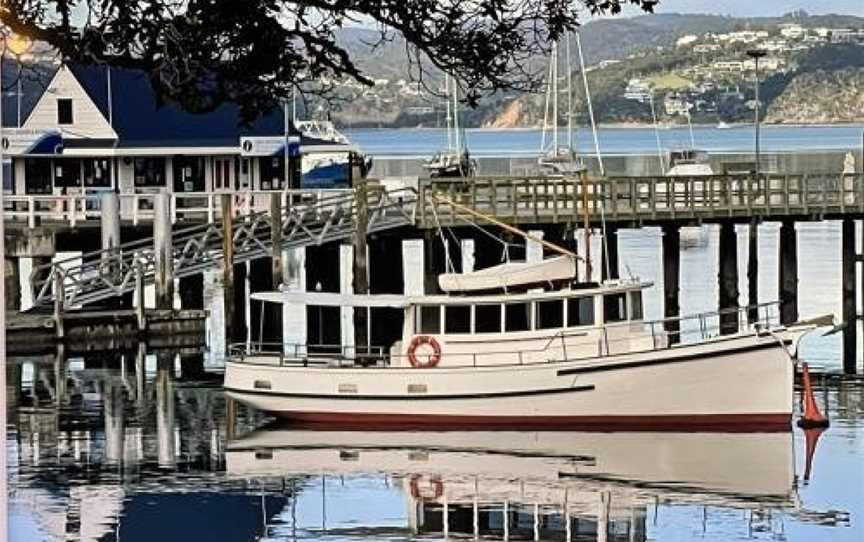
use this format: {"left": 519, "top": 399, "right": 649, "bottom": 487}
{"left": 225, "top": 334, "right": 794, "bottom": 430}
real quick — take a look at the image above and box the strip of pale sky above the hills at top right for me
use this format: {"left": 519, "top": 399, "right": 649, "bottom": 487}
{"left": 629, "top": 0, "right": 864, "bottom": 17}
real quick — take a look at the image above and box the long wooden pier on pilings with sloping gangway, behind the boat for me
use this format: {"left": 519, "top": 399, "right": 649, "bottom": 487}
{"left": 4, "top": 173, "right": 864, "bottom": 373}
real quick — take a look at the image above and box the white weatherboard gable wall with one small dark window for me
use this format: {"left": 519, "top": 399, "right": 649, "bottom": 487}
{"left": 23, "top": 66, "right": 117, "bottom": 139}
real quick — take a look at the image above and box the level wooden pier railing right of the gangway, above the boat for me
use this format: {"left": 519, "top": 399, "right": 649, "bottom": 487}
{"left": 418, "top": 173, "right": 864, "bottom": 227}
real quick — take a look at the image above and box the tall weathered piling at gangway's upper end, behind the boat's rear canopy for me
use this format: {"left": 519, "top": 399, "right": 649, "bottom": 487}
{"left": 352, "top": 164, "right": 369, "bottom": 352}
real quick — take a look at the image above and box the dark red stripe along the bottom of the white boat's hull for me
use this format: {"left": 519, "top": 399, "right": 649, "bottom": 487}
{"left": 273, "top": 411, "right": 792, "bottom": 432}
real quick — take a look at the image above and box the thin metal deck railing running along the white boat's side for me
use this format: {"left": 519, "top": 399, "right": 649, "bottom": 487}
{"left": 229, "top": 302, "right": 782, "bottom": 367}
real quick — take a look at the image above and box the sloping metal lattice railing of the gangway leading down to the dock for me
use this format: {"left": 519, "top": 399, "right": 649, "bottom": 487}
{"left": 32, "top": 189, "right": 416, "bottom": 307}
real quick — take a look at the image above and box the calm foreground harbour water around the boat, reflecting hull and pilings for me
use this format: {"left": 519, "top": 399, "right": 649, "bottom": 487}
{"left": 7, "top": 223, "right": 864, "bottom": 542}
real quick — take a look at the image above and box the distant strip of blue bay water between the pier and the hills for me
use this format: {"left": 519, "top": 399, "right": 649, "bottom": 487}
{"left": 346, "top": 124, "right": 864, "bottom": 155}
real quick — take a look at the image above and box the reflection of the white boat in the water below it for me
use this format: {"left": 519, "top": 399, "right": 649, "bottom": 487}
{"left": 225, "top": 427, "right": 798, "bottom": 540}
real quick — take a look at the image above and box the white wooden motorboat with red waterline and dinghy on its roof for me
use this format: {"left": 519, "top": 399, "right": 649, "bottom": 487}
{"left": 224, "top": 227, "right": 816, "bottom": 430}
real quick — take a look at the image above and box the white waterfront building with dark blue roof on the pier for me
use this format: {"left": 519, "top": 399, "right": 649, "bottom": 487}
{"left": 2, "top": 65, "right": 356, "bottom": 199}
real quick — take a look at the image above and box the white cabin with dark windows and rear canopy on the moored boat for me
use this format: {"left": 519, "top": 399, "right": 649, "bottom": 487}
{"left": 252, "top": 280, "right": 666, "bottom": 368}
